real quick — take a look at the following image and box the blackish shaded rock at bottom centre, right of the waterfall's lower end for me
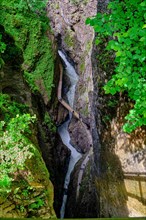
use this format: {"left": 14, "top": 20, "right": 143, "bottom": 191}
{"left": 65, "top": 154, "right": 99, "bottom": 218}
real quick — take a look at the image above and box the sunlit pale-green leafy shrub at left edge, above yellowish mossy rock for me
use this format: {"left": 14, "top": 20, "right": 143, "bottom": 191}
{"left": 0, "top": 94, "right": 35, "bottom": 192}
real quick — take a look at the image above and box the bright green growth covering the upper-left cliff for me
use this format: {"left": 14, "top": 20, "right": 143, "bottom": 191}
{"left": 0, "top": 0, "right": 54, "bottom": 99}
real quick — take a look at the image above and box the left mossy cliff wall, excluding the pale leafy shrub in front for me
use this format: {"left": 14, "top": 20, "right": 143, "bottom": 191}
{"left": 0, "top": 0, "right": 55, "bottom": 218}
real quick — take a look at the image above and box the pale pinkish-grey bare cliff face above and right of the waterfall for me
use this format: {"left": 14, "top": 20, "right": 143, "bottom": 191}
{"left": 48, "top": 0, "right": 97, "bottom": 117}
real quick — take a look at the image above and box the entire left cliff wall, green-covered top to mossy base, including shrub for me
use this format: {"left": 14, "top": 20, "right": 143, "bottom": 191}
{"left": 0, "top": 1, "right": 56, "bottom": 218}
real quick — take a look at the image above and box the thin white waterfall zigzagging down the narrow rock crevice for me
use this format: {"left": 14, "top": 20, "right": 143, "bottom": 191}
{"left": 58, "top": 50, "right": 82, "bottom": 218}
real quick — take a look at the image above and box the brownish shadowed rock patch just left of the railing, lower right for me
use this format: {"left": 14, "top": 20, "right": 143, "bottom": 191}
{"left": 95, "top": 148, "right": 129, "bottom": 217}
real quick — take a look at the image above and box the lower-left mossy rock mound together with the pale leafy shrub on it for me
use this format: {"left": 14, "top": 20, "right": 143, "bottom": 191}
{"left": 0, "top": 94, "right": 55, "bottom": 218}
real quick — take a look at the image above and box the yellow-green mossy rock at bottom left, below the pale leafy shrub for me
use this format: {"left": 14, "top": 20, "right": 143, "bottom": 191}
{"left": 0, "top": 146, "right": 55, "bottom": 218}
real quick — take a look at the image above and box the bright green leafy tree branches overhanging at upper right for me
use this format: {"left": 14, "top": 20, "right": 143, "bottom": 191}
{"left": 86, "top": 0, "right": 146, "bottom": 132}
